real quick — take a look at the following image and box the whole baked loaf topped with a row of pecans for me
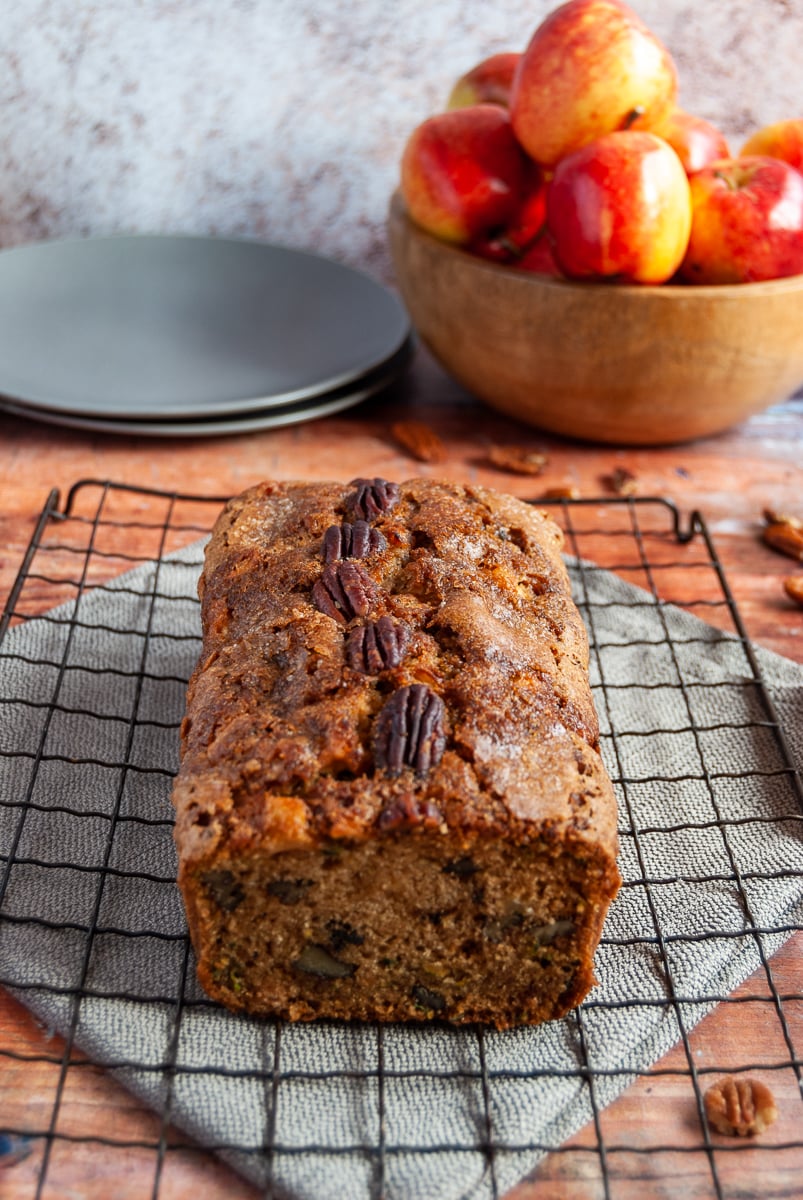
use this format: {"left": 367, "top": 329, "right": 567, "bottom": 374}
{"left": 173, "top": 479, "right": 619, "bottom": 1028}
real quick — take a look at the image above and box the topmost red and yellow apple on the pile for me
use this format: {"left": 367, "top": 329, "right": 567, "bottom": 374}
{"left": 510, "top": 0, "right": 677, "bottom": 166}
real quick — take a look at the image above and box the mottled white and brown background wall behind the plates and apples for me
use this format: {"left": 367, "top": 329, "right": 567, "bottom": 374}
{"left": 0, "top": 0, "right": 803, "bottom": 280}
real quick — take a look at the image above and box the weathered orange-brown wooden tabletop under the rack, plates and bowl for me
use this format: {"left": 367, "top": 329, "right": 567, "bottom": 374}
{"left": 0, "top": 343, "right": 803, "bottom": 1200}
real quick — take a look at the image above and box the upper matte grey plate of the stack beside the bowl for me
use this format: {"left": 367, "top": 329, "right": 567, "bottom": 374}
{"left": 0, "top": 235, "right": 409, "bottom": 420}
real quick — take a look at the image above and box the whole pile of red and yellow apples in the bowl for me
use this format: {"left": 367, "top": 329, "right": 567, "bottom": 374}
{"left": 401, "top": 0, "right": 803, "bottom": 283}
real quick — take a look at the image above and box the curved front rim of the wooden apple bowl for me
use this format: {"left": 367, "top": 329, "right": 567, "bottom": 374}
{"left": 389, "top": 188, "right": 803, "bottom": 300}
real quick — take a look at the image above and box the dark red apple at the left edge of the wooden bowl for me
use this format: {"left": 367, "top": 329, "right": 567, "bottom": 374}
{"left": 401, "top": 104, "right": 527, "bottom": 245}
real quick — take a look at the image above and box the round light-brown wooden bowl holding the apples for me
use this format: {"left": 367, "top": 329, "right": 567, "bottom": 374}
{"left": 389, "top": 194, "right": 803, "bottom": 445}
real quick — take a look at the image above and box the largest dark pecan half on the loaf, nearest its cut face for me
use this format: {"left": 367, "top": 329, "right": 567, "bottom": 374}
{"left": 373, "top": 683, "right": 447, "bottom": 775}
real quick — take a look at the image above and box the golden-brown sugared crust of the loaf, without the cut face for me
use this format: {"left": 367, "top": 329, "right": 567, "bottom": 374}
{"left": 174, "top": 480, "right": 618, "bottom": 1024}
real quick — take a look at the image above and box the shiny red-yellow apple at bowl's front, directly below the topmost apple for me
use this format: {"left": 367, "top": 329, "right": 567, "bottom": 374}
{"left": 546, "top": 130, "right": 691, "bottom": 283}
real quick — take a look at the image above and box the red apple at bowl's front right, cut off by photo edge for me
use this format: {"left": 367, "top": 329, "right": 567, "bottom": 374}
{"left": 681, "top": 155, "right": 803, "bottom": 283}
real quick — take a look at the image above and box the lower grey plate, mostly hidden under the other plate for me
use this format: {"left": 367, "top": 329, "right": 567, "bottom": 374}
{"left": 0, "top": 343, "right": 411, "bottom": 438}
